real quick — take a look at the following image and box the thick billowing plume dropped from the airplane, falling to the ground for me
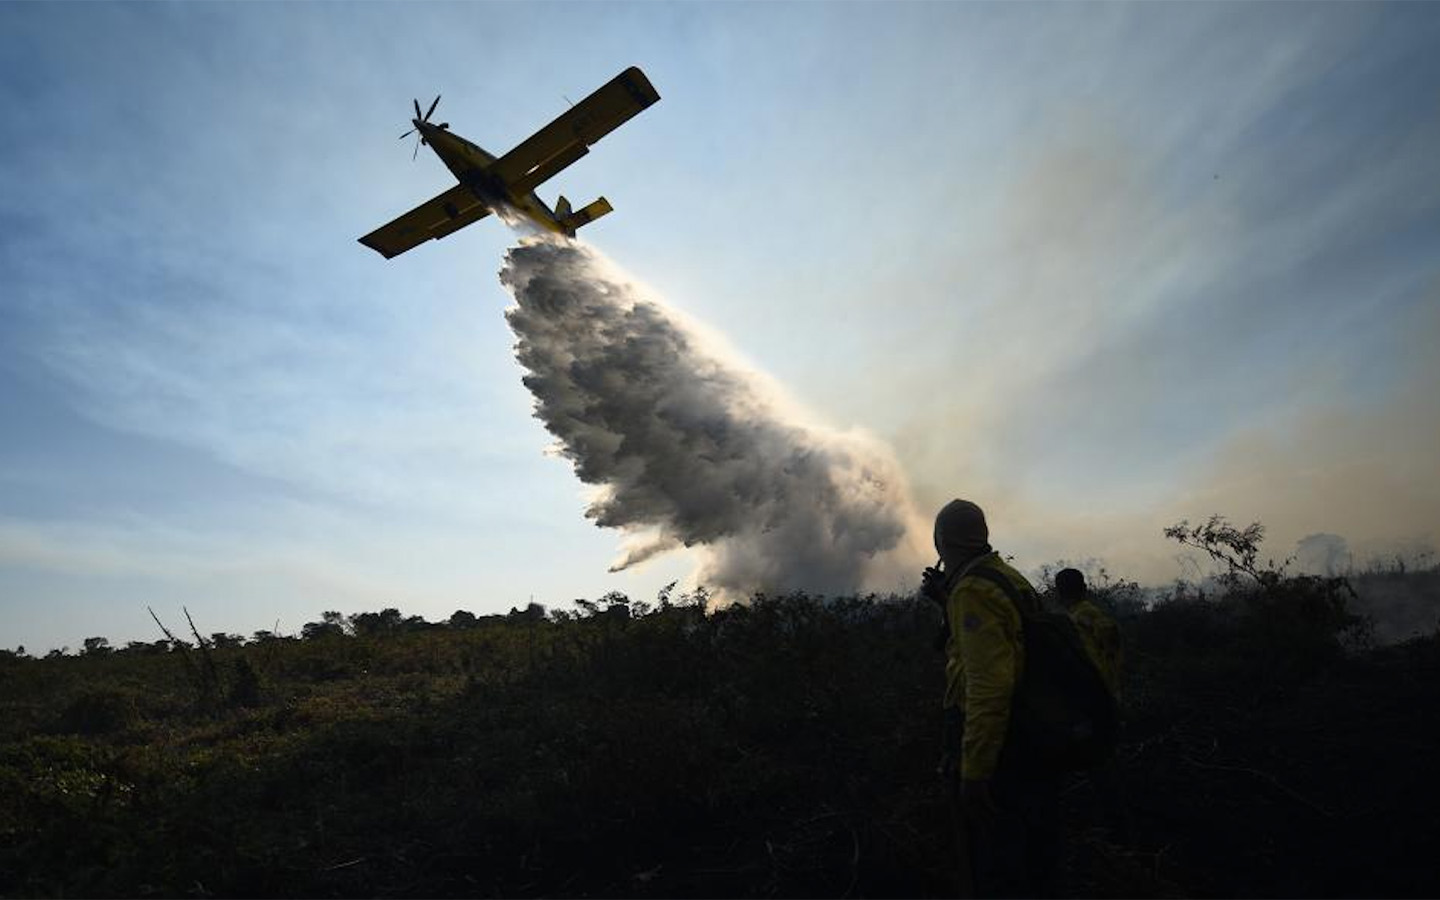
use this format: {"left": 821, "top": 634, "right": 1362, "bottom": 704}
{"left": 500, "top": 238, "right": 923, "bottom": 600}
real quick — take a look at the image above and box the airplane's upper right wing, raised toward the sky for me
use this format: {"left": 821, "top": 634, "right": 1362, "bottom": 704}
{"left": 488, "top": 66, "right": 660, "bottom": 196}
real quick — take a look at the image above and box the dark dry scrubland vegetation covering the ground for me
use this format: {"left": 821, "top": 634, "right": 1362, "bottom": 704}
{"left": 0, "top": 520, "right": 1440, "bottom": 896}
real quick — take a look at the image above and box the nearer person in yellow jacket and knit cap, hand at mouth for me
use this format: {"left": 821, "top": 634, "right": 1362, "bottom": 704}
{"left": 923, "top": 500, "right": 1061, "bottom": 897}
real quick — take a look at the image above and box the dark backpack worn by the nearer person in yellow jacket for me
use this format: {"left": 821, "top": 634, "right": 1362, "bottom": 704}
{"left": 968, "top": 566, "right": 1120, "bottom": 775}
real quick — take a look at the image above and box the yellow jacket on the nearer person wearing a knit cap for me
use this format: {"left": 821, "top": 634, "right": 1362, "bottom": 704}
{"left": 945, "top": 553, "right": 1035, "bottom": 779}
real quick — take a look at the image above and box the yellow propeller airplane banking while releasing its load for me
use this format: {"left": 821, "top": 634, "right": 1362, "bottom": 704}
{"left": 360, "top": 66, "right": 660, "bottom": 259}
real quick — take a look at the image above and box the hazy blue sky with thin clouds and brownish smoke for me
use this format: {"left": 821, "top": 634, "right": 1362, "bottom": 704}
{"left": 0, "top": 1, "right": 1440, "bottom": 652}
